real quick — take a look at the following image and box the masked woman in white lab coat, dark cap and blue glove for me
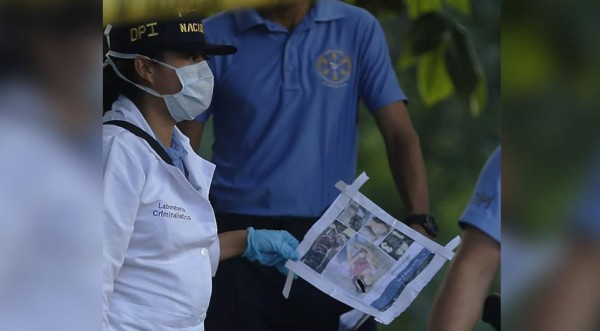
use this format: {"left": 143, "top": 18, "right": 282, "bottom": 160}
{"left": 103, "top": 18, "right": 298, "bottom": 331}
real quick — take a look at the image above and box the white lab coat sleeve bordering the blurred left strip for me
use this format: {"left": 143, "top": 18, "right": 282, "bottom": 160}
{"left": 102, "top": 136, "right": 145, "bottom": 330}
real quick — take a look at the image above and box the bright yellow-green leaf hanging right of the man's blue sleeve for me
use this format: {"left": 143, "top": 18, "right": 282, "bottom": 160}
{"left": 417, "top": 43, "right": 454, "bottom": 107}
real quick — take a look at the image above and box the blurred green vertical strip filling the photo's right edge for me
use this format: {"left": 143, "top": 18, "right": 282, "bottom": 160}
{"left": 501, "top": 0, "right": 600, "bottom": 330}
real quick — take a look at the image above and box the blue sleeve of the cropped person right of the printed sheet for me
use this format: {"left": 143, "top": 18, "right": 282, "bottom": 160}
{"left": 459, "top": 147, "right": 502, "bottom": 243}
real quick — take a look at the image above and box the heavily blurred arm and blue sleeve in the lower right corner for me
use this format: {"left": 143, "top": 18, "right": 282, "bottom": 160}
{"left": 522, "top": 156, "right": 600, "bottom": 331}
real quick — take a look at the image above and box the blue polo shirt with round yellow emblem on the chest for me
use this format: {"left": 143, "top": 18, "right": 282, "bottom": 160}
{"left": 197, "top": 1, "right": 406, "bottom": 217}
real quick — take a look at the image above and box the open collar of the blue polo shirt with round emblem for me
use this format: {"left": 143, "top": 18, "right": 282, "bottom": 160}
{"left": 235, "top": 0, "right": 346, "bottom": 32}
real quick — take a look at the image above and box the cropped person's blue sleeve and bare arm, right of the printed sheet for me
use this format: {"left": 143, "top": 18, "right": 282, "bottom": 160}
{"left": 429, "top": 147, "right": 501, "bottom": 331}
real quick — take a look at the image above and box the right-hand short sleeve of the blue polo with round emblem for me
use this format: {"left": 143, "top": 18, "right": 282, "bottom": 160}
{"left": 358, "top": 14, "right": 407, "bottom": 113}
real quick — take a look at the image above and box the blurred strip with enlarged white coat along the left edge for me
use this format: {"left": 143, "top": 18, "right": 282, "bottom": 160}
{"left": 0, "top": 1, "right": 102, "bottom": 331}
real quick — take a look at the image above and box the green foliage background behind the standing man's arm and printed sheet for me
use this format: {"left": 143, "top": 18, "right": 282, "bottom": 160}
{"left": 200, "top": 0, "right": 501, "bottom": 330}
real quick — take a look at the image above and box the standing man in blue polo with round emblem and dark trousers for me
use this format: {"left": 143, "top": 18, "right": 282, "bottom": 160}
{"left": 182, "top": 0, "right": 437, "bottom": 331}
